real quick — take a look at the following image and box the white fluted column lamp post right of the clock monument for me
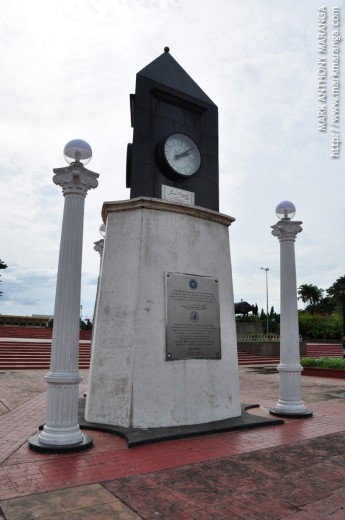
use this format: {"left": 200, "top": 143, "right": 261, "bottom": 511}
{"left": 270, "top": 201, "right": 313, "bottom": 417}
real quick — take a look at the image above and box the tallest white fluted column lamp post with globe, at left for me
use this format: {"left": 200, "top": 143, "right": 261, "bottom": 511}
{"left": 29, "top": 139, "right": 99, "bottom": 452}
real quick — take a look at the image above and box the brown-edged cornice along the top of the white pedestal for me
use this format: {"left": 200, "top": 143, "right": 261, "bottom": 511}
{"left": 102, "top": 197, "right": 236, "bottom": 227}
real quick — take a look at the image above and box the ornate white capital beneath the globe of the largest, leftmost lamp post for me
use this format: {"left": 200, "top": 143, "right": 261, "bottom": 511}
{"left": 53, "top": 162, "right": 99, "bottom": 198}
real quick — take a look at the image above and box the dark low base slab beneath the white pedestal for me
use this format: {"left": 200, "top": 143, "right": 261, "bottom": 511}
{"left": 78, "top": 399, "right": 284, "bottom": 448}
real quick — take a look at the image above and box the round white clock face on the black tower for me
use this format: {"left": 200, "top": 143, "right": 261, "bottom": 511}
{"left": 163, "top": 134, "right": 201, "bottom": 177}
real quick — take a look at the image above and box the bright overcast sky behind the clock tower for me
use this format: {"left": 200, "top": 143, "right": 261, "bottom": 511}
{"left": 0, "top": 0, "right": 345, "bottom": 317}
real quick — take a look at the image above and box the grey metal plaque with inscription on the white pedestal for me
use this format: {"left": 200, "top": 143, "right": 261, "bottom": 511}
{"left": 165, "top": 273, "right": 221, "bottom": 361}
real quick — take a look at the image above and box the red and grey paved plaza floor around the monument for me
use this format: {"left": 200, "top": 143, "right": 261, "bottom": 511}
{"left": 0, "top": 366, "right": 345, "bottom": 520}
